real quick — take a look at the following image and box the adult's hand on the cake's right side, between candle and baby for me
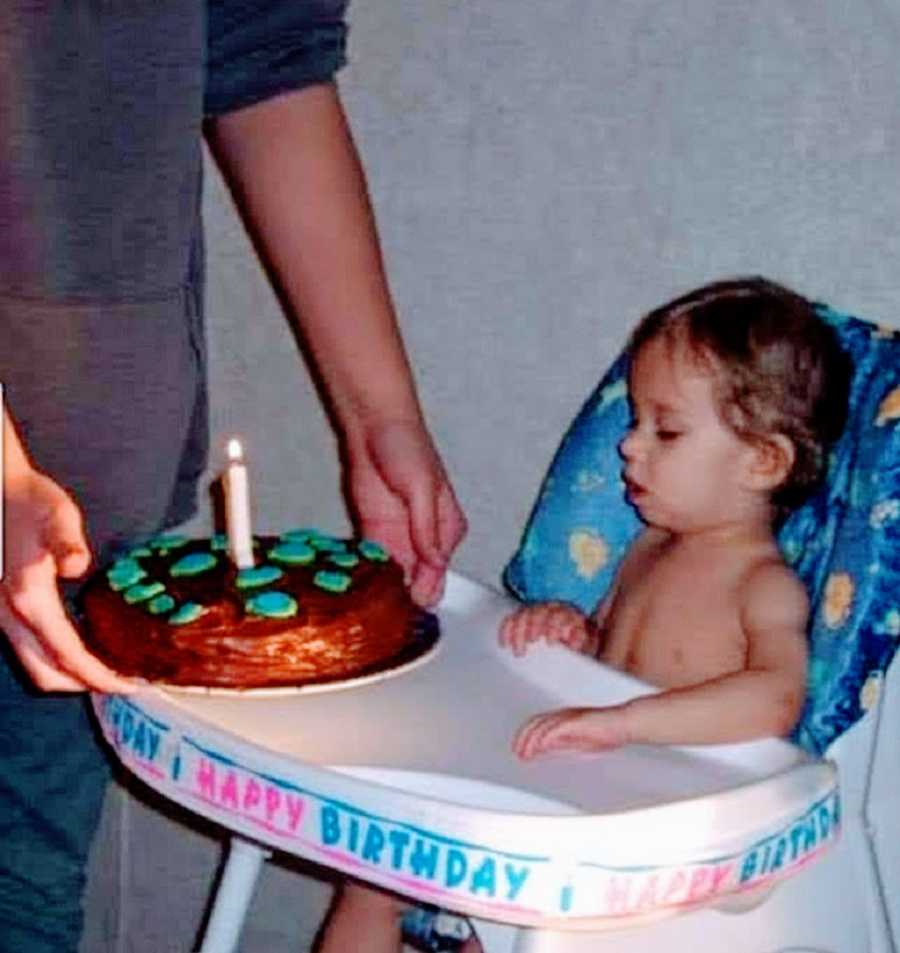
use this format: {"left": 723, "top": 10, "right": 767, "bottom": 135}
{"left": 347, "top": 421, "right": 466, "bottom": 606}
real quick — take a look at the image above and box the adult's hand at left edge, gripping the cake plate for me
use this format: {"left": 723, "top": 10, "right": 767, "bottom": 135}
{"left": 0, "top": 469, "right": 134, "bottom": 693}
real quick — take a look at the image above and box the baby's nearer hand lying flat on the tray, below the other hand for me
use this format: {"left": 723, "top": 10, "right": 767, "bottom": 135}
{"left": 513, "top": 707, "right": 628, "bottom": 761}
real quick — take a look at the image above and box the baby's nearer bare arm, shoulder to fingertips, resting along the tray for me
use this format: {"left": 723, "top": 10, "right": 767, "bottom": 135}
{"left": 513, "top": 563, "right": 809, "bottom": 758}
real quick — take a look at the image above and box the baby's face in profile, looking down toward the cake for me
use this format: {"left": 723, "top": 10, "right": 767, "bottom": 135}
{"left": 620, "top": 339, "right": 760, "bottom": 532}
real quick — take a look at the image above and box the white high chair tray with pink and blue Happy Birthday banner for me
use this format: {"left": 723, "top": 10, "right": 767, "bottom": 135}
{"left": 94, "top": 575, "right": 840, "bottom": 930}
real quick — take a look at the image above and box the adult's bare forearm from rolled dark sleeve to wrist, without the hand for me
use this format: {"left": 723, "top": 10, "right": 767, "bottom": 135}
{"left": 209, "top": 85, "right": 421, "bottom": 448}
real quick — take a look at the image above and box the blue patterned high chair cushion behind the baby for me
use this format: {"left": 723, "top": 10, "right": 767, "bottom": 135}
{"left": 504, "top": 306, "right": 900, "bottom": 754}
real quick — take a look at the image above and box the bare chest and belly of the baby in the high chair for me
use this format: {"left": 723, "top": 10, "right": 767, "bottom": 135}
{"left": 603, "top": 556, "right": 747, "bottom": 688}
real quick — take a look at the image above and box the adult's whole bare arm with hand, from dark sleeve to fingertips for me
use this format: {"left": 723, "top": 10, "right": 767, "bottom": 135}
{"left": 208, "top": 83, "right": 465, "bottom": 604}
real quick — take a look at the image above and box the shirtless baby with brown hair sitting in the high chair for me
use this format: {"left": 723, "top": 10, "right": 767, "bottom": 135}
{"left": 500, "top": 278, "right": 849, "bottom": 759}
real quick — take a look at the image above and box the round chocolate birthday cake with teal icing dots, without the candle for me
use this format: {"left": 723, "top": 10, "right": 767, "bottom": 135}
{"left": 83, "top": 530, "right": 438, "bottom": 689}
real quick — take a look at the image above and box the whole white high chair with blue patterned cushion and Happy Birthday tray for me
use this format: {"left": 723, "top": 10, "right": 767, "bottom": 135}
{"left": 94, "top": 307, "right": 900, "bottom": 953}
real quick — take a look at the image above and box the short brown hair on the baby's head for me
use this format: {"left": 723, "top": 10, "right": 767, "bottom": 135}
{"left": 630, "top": 277, "right": 851, "bottom": 508}
